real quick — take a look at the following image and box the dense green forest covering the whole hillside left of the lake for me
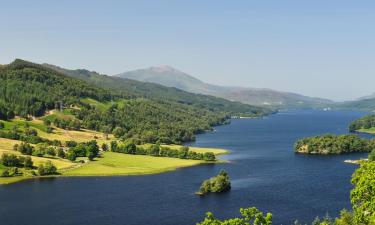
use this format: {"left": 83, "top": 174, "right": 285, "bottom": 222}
{"left": 0, "top": 59, "right": 270, "bottom": 143}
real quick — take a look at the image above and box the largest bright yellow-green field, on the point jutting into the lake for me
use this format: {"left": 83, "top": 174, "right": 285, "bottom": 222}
{"left": 63, "top": 152, "right": 209, "bottom": 176}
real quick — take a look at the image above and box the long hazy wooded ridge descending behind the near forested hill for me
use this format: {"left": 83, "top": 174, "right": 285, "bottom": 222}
{"left": 43, "top": 64, "right": 273, "bottom": 117}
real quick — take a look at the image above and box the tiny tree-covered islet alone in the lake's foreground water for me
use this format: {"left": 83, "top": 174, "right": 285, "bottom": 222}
{"left": 196, "top": 170, "right": 231, "bottom": 196}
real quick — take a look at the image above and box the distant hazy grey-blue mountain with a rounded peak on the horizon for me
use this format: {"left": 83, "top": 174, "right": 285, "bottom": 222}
{"left": 115, "top": 66, "right": 333, "bottom": 108}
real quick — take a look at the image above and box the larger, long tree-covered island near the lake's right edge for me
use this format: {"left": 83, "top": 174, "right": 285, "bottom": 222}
{"left": 294, "top": 134, "right": 375, "bottom": 154}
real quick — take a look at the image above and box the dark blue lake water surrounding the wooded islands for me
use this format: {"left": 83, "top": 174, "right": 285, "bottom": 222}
{"left": 0, "top": 111, "right": 366, "bottom": 225}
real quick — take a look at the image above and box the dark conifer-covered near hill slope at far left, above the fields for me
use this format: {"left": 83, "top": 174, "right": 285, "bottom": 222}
{"left": 0, "top": 59, "right": 111, "bottom": 119}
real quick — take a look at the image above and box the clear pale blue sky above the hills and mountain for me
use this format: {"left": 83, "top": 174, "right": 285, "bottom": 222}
{"left": 0, "top": 0, "right": 375, "bottom": 101}
